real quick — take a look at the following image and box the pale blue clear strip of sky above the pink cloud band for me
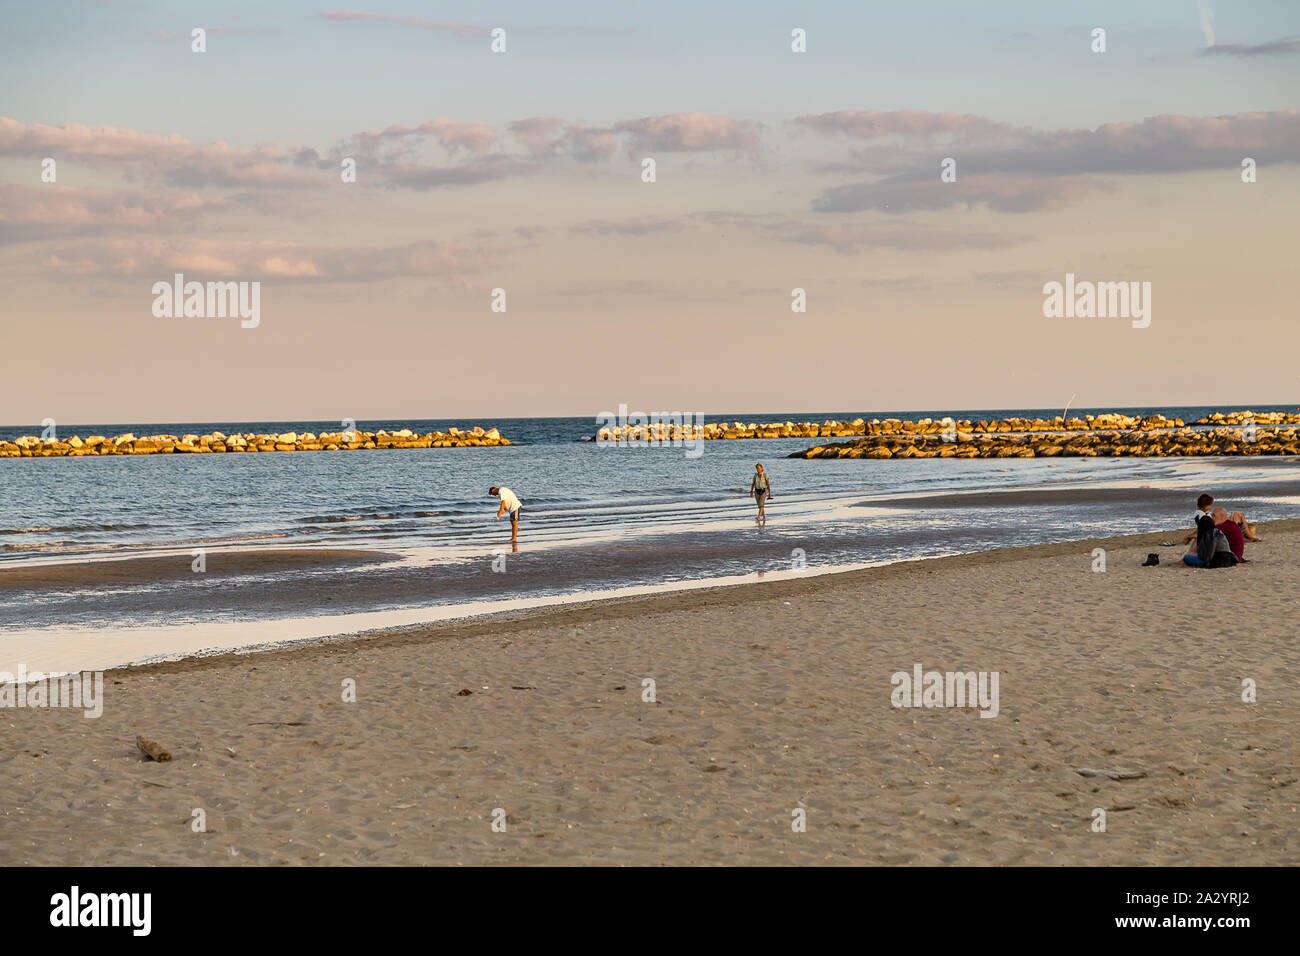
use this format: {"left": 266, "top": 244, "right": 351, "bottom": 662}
{"left": 10, "top": 0, "right": 1300, "bottom": 147}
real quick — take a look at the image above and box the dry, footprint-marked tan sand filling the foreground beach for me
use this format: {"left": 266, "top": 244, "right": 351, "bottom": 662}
{"left": 0, "top": 520, "right": 1300, "bottom": 866}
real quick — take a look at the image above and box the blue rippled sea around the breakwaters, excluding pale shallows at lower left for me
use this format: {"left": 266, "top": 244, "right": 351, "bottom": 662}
{"left": 0, "top": 406, "right": 1300, "bottom": 639}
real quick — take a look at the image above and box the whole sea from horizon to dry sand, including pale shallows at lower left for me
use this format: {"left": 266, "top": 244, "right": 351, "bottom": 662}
{"left": 0, "top": 406, "right": 1300, "bottom": 670}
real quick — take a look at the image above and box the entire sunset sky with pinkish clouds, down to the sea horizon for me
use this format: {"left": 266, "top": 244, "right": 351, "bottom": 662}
{"left": 0, "top": 0, "right": 1300, "bottom": 424}
